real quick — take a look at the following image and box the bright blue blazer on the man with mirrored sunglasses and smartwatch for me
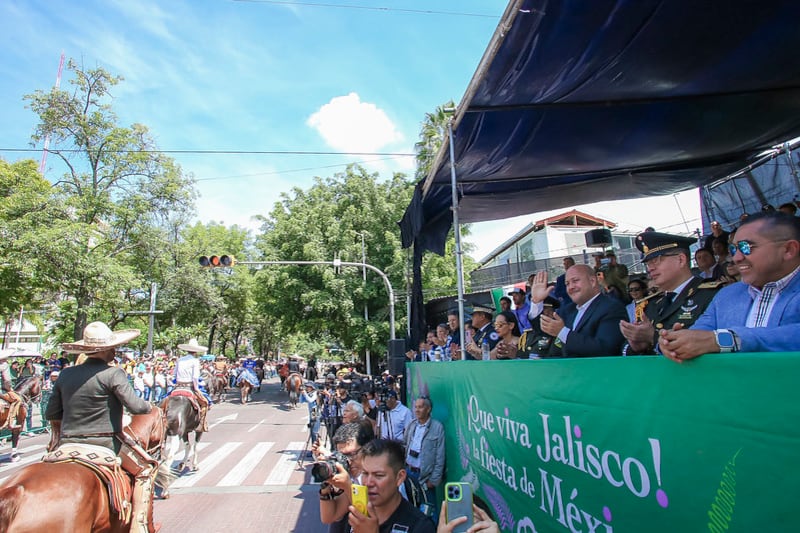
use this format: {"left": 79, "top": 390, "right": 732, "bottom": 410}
{"left": 689, "top": 274, "right": 800, "bottom": 352}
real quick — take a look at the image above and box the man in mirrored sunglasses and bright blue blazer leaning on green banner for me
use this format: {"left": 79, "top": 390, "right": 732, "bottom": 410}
{"left": 659, "top": 211, "right": 800, "bottom": 362}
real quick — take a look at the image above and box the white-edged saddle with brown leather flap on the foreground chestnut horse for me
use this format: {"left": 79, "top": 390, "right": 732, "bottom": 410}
{"left": 42, "top": 442, "right": 133, "bottom": 524}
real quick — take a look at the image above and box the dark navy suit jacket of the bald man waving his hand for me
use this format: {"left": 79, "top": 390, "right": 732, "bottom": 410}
{"left": 558, "top": 293, "right": 628, "bottom": 357}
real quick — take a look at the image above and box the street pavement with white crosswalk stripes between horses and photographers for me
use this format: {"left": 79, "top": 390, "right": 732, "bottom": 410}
{"left": 0, "top": 378, "right": 328, "bottom": 533}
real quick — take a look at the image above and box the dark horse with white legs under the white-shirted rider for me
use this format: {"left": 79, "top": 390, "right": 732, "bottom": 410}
{"left": 162, "top": 389, "right": 203, "bottom": 480}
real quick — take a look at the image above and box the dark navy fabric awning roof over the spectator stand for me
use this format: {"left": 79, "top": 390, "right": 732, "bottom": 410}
{"left": 401, "top": 0, "right": 800, "bottom": 253}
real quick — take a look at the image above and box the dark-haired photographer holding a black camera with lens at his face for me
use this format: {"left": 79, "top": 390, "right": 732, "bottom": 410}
{"left": 311, "top": 422, "right": 375, "bottom": 533}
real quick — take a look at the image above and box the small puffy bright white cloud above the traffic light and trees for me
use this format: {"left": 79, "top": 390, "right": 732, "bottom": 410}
{"left": 306, "top": 93, "right": 404, "bottom": 152}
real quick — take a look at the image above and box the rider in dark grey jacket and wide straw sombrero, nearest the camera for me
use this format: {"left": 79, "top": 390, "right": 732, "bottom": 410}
{"left": 45, "top": 322, "right": 158, "bottom": 533}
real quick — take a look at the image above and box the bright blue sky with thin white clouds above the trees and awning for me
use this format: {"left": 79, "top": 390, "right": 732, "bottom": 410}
{"left": 0, "top": 0, "right": 699, "bottom": 259}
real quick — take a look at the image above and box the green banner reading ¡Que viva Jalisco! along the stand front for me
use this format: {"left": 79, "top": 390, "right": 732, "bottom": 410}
{"left": 407, "top": 353, "right": 800, "bottom": 533}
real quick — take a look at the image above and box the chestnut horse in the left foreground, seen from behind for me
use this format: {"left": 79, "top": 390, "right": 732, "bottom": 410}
{"left": 0, "top": 408, "right": 164, "bottom": 533}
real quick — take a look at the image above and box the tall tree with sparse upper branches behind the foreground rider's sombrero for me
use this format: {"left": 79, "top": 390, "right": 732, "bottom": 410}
{"left": 25, "top": 60, "right": 195, "bottom": 338}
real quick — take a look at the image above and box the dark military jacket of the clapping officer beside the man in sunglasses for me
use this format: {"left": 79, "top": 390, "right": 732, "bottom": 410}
{"left": 644, "top": 277, "right": 722, "bottom": 353}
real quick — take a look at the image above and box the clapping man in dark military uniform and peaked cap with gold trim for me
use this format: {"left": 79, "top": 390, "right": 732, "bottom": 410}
{"left": 619, "top": 231, "right": 722, "bottom": 355}
